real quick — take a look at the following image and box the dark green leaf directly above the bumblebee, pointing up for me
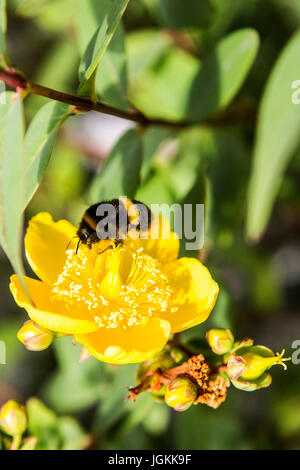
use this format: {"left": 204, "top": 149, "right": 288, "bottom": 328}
{"left": 88, "top": 129, "right": 143, "bottom": 203}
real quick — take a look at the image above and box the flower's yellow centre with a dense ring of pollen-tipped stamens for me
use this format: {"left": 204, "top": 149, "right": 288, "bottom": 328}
{"left": 52, "top": 246, "right": 172, "bottom": 329}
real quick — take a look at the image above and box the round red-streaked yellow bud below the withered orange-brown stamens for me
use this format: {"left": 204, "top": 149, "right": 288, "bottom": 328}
{"left": 165, "top": 375, "right": 198, "bottom": 411}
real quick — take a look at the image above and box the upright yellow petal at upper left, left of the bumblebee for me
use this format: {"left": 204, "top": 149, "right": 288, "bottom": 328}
{"left": 25, "top": 212, "right": 76, "bottom": 285}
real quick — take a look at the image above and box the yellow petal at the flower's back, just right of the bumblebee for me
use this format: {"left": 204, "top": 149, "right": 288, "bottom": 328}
{"left": 129, "top": 215, "right": 179, "bottom": 264}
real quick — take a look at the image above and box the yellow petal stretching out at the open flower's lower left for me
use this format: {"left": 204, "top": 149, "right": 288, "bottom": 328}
{"left": 9, "top": 274, "right": 98, "bottom": 334}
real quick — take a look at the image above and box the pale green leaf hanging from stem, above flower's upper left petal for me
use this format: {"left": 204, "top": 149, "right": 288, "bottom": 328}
{"left": 24, "top": 101, "right": 70, "bottom": 207}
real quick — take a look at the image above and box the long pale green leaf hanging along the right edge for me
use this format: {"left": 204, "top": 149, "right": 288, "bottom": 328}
{"left": 246, "top": 31, "right": 300, "bottom": 240}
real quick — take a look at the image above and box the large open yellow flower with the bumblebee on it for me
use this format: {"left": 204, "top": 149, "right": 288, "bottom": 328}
{"left": 10, "top": 212, "right": 219, "bottom": 364}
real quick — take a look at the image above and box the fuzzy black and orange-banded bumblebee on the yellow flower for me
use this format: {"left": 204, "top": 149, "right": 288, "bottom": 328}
{"left": 76, "top": 197, "right": 152, "bottom": 253}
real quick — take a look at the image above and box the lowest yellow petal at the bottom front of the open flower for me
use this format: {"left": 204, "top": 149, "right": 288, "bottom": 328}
{"left": 75, "top": 318, "right": 170, "bottom": 364}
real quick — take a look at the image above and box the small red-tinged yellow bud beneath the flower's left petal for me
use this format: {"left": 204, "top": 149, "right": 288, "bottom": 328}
{"left": 17, "top": 320, "right": 55, "bottom": 351}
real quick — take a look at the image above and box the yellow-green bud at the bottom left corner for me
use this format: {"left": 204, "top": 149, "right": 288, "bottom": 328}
{"left": 0, "top": 400, "right": 27, "bottom": 436}
